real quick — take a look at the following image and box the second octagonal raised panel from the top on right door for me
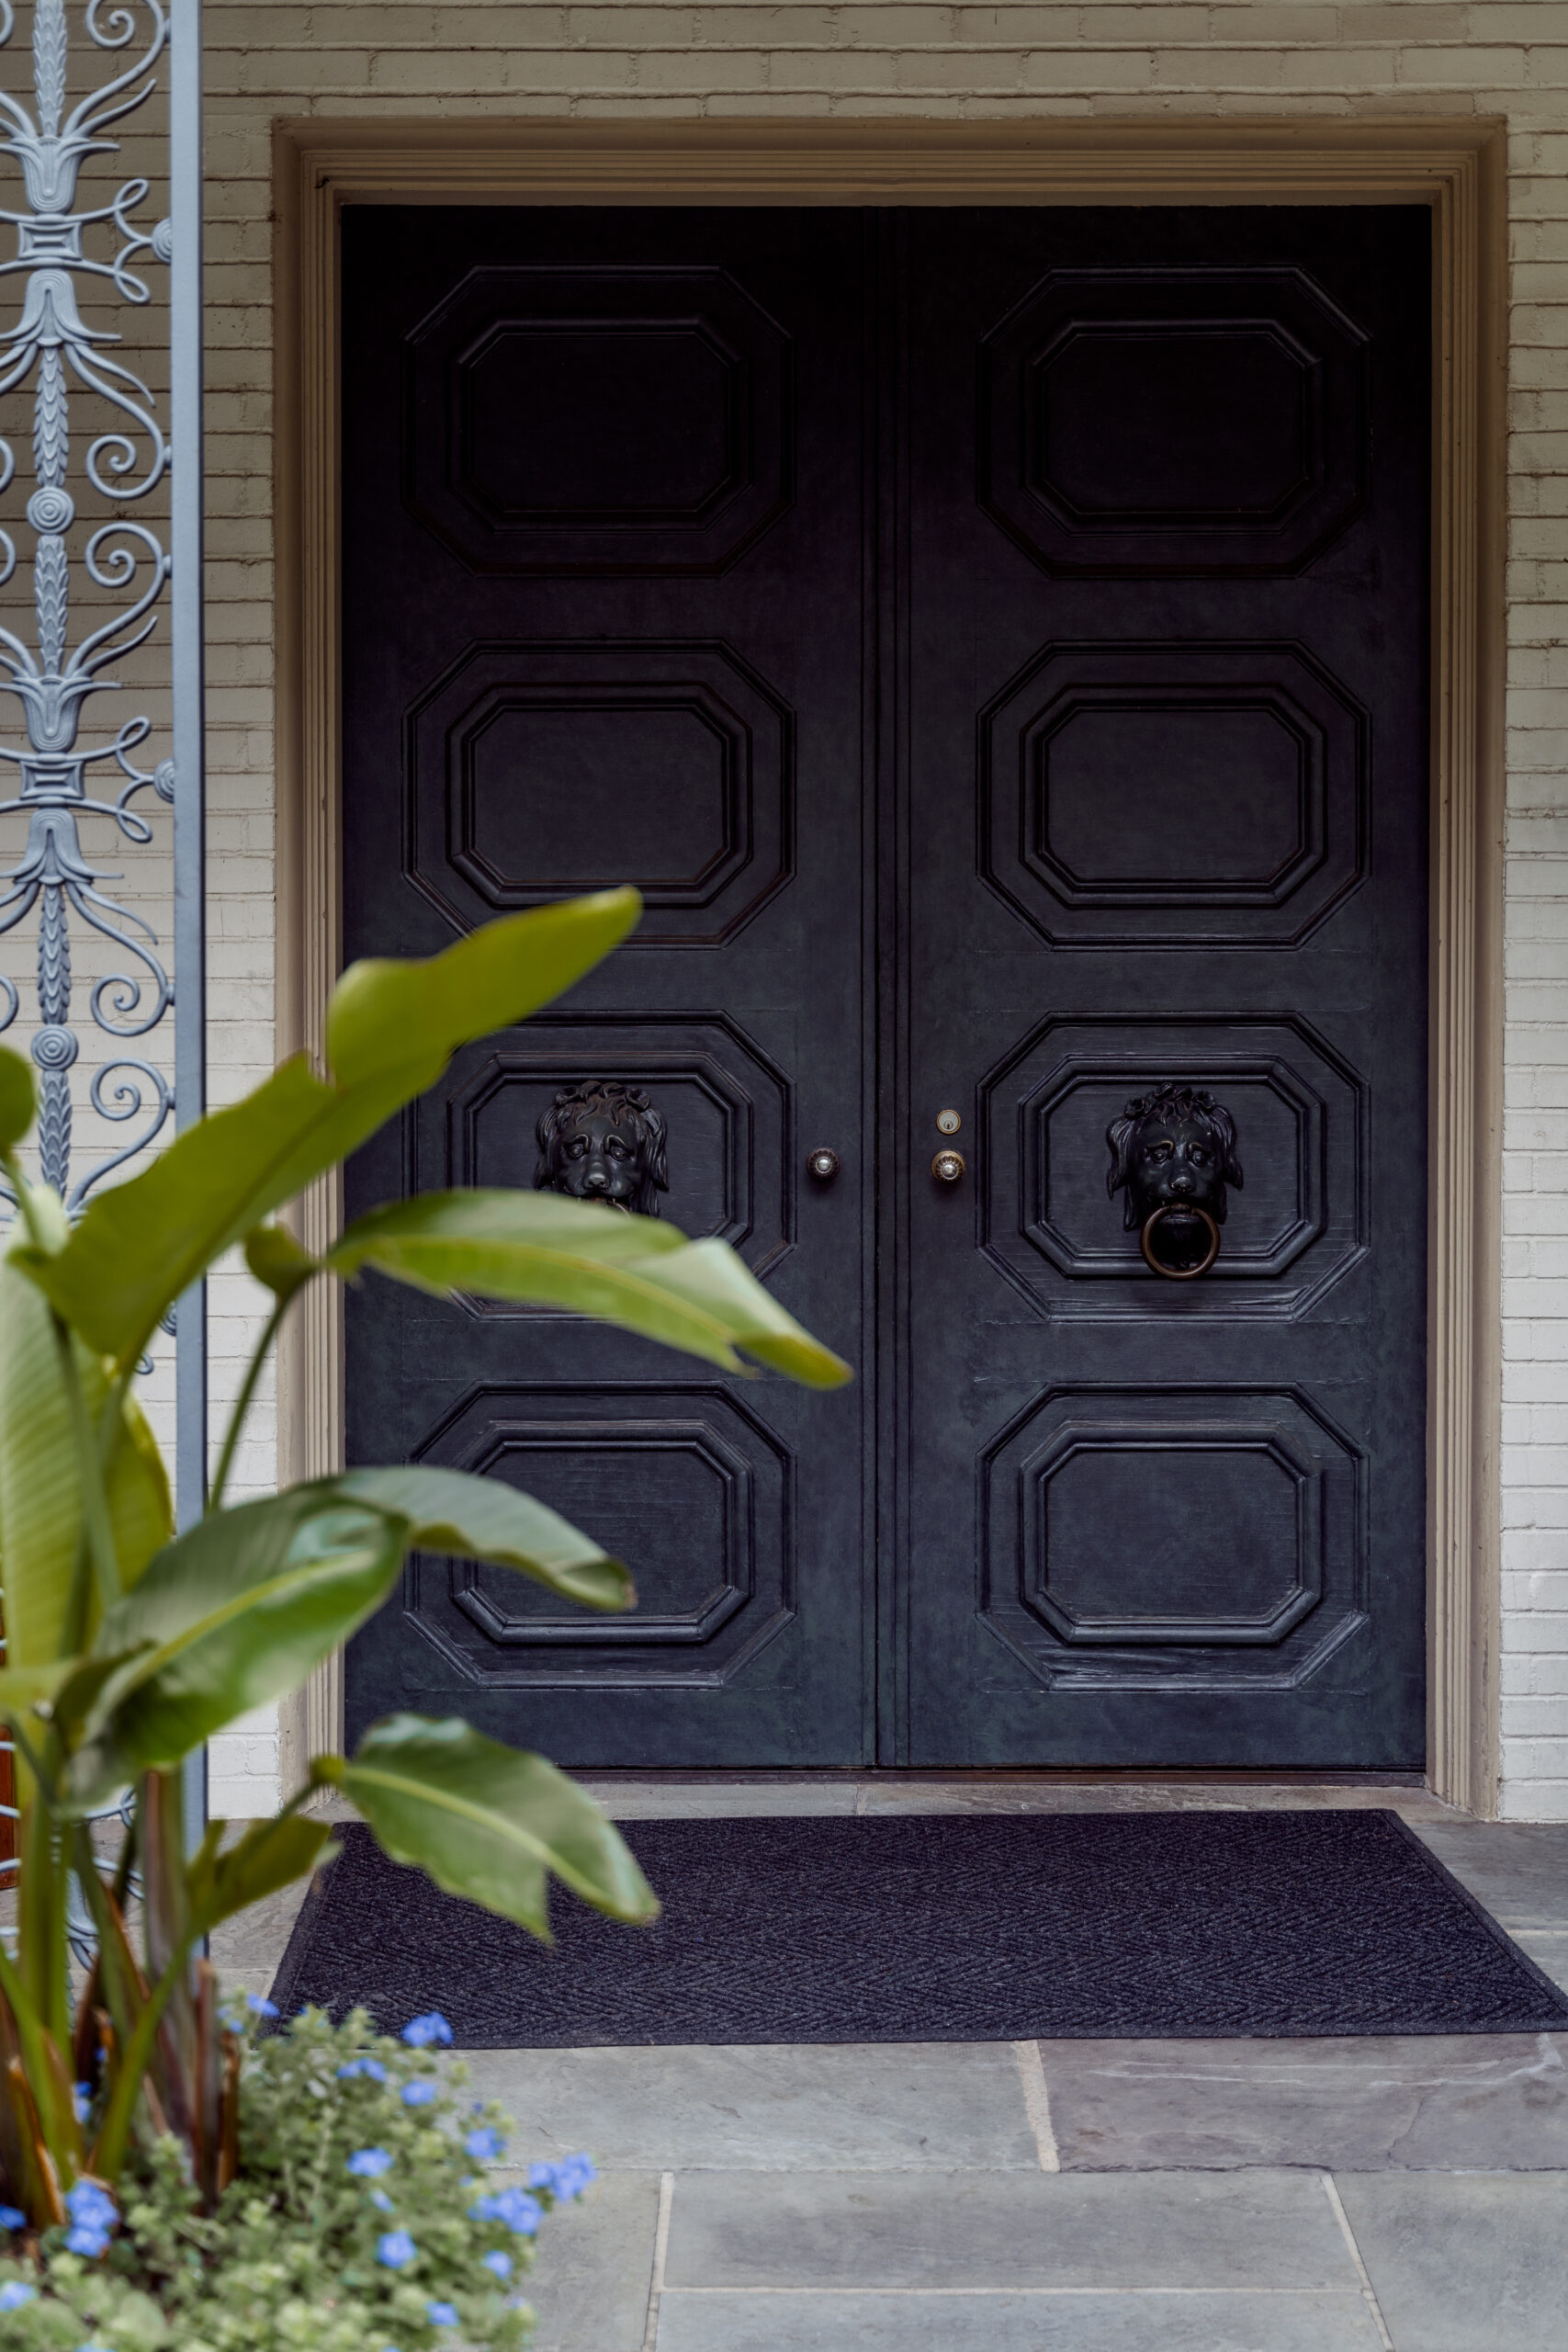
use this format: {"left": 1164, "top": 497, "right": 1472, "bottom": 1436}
{"left": 980, "top": 642, "right": 1366, "bottom": 948}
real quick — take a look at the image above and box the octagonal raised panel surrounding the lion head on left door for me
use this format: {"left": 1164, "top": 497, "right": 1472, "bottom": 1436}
{"left": 413, "top": 1012, "right": 795, "bottom": 1319}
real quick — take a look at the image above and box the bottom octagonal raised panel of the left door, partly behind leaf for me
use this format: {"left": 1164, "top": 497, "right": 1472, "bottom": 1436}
{"left": 404, "top": 1385, "right": 792, "bottom": 1687}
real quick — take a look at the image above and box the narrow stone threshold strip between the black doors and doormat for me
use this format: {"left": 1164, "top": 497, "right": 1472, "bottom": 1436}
{"left": 573, "top": 1767, "right": 1472, "bottom": 1820}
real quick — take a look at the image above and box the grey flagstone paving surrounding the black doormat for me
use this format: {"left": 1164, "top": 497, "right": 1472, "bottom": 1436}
{"left": 219, "top": 1776, "right": 1568, "bottom": 2352}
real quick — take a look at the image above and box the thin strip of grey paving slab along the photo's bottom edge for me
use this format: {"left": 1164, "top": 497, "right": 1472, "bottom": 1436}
{"left": 656, "top": 2290, "right": 1380, "bottom": 2352}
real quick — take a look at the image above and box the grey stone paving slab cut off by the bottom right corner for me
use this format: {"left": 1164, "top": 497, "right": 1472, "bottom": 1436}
{"left": 1337, "top": 2173, "right": 1568, "bottom": 2352}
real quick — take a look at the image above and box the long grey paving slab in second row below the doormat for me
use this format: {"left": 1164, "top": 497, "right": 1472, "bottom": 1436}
{"left": 665, "top": 2171, "right": 1361, "bottom": 2293}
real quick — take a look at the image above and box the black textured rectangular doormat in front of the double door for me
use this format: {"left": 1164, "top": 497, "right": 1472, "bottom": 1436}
{"left": 273, "top": 1811, "right": 1568, "bottom": 2049}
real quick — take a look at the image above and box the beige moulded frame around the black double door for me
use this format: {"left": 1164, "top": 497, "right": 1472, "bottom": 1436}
{"left": 273, "top": 115, "right": 1506, "bottom": 1818}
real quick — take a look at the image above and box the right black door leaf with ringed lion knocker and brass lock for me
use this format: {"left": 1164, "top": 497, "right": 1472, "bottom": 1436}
{"left": 894, "top": 209, "right": 1429, "bottom": 1769}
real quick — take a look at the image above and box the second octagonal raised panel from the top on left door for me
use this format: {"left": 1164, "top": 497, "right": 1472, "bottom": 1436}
{"left": 404, "top": 639, "right": 795, "bottom": 948}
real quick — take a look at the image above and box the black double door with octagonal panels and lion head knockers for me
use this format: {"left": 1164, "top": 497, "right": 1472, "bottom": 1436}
{"left": 344, "top": 207, "right": 1429, "bottom": 1769}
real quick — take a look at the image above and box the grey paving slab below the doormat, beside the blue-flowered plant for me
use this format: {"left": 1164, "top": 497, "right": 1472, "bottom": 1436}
{"left": 463, "top": 2041, "right": 1039, "bottom": 2171}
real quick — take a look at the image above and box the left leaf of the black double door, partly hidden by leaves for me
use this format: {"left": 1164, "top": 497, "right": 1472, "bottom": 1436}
{"left": 341, "top": 207, "right": 872, "bottom": 1767}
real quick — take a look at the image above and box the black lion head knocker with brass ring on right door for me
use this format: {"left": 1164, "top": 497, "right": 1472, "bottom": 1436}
{"left": 1105, "top": 1084, "right": 1241, "bottom": 1282}
